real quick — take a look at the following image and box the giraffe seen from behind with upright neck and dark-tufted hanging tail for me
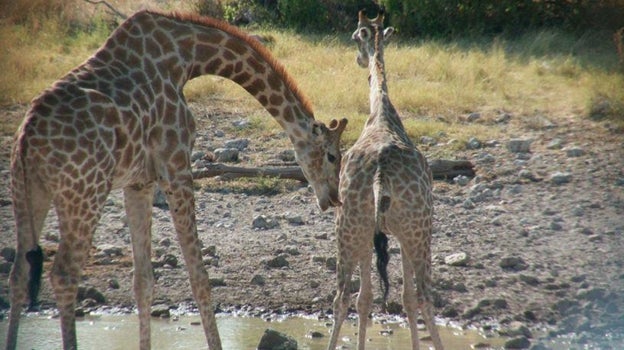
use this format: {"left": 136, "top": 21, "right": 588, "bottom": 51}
{"left": 328, "top": 11, "right": 442, "bottom": 350}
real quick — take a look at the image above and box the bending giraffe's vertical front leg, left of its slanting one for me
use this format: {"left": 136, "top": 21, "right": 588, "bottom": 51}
{"left": 124, "top": 184, "right": 154, "bottom": 350}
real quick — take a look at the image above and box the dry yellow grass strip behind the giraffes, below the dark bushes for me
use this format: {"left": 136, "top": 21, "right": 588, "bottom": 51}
{"left": 0, "top": 0, "right": 624, "bottom": 144}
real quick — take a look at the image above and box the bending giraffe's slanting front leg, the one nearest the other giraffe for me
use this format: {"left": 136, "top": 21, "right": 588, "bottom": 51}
{"left": 165, "top": 178, "right": 221, "bottom": 350}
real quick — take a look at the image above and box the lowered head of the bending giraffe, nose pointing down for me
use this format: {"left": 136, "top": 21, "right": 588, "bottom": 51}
{"left": 294, "top": 119, "right": 347, "bottom": 211}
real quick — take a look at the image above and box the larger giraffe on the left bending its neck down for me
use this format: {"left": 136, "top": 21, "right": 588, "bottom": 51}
{"left": 6, "top": 11, "right": 346, "bottom": 349}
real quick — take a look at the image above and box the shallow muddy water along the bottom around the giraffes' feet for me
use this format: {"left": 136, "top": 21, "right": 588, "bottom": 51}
{"left": 0, "top": 315, "right": 503, "bottom": 350}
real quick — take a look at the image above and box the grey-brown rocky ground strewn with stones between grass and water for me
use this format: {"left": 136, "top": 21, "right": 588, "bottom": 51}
{"left": 0, "top": 104, "right": 624, "bottom": 349}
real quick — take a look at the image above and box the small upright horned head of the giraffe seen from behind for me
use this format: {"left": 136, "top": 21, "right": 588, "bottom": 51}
{"left": 351, "top": 10, "right": 394, "bottom": 68}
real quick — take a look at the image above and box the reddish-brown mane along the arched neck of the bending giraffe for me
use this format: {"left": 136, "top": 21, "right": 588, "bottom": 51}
{"left": 146, "top": 10, "right": 314, "bottom": 119}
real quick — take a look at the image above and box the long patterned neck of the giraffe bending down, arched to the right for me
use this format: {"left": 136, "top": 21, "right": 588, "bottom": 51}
{"left": 154, "top": 9, "right": 314, "bottom": 138}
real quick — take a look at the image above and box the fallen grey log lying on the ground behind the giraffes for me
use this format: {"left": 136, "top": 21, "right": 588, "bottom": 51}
{"left": 193, "top": 159, "right": 475, "bottom": 182}
